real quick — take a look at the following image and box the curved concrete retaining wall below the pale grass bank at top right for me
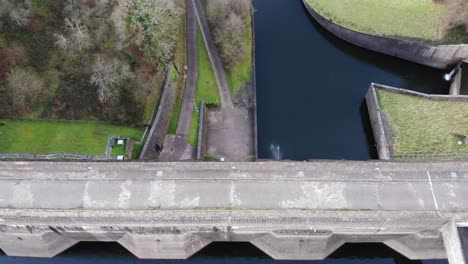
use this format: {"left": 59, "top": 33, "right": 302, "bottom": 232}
{"left": 303, "top": 0, "right": 468, "bottom": 69}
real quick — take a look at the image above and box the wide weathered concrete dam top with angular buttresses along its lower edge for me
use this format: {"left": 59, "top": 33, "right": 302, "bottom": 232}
{"left": 0, "top": 161, "right": 468, "bottom": 259}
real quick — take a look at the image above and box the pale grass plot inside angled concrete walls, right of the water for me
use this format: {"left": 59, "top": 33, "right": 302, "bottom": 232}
{"left": 377, "top": 89, "right": 468, "bottom": 155}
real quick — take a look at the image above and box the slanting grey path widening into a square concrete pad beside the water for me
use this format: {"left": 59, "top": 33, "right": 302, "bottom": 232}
{"left": 191, "top": 0, "right": 255, "bottom": 161}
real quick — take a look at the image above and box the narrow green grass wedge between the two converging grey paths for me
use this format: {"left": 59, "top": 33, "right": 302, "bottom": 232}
{"left": 188, "top": 28, "right": 221, "bottom": 147}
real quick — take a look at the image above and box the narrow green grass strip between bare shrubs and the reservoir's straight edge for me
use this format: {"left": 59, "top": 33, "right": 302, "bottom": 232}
{"left": 226, "top": 14, "right": 252, "bottom": 99}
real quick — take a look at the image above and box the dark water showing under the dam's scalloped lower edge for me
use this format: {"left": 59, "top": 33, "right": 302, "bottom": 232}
{"left": 0, "top": 243, "right": 447, "bottom": 264}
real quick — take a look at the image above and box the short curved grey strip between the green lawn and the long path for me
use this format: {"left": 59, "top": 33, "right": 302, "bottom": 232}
{"left": 139, "top": 64, "right": 176, "bottom": 160}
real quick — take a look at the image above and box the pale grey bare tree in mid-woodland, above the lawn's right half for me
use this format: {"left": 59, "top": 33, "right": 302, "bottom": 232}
{"left": 90, "top": 56, "right": 133, "bottom": 103}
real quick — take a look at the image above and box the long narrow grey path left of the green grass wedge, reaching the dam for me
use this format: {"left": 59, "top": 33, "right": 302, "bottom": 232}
{"left": 159, "top": 0, "right": 198, "bottom": 161}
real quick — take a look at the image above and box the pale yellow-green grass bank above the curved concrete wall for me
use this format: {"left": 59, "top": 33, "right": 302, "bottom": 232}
{"left": 307, "top": 0, "right": 446, "bottom": 41}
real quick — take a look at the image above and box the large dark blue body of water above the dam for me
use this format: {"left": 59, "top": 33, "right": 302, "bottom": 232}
{"left": 254, "top": 0, "right": 449, "bottom": 160}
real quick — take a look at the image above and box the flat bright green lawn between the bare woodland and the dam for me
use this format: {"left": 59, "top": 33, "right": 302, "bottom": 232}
{"left": 0, "top": 119, "right": 143, "bottom": 155}
